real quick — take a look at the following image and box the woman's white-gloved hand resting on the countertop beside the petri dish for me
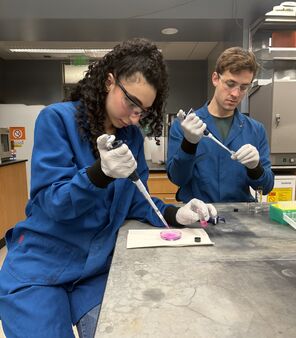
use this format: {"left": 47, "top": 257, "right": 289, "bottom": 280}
{"left": 176, "top": 198, "right": 217, "bottom": 225}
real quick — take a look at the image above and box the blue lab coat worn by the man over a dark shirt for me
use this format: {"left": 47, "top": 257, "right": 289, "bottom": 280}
{"left": 167, "top": 103, "right": 274, "bottom": 203}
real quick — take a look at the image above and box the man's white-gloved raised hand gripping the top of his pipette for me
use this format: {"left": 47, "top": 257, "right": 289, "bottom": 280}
{"left": 177, "top": 109, "right": 207, "bottom": 144}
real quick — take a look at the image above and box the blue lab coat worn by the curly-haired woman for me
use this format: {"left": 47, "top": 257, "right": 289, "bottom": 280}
{"left": 0, "top": 102, "right": 166, "bottom": 338}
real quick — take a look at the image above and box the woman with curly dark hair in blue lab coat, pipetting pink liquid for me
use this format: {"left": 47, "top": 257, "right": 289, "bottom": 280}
{"left": 0, "top": 39, "right": 216, "bottom": 338}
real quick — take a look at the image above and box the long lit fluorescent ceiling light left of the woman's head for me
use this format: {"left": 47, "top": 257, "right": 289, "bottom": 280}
{"left": 9, "top": 48, "right": 112, "bottom": 57}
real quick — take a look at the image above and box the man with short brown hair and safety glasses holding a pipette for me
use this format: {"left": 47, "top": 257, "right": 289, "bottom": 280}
{"left": 167, "top": 47, "right": 274, "bottom": 202}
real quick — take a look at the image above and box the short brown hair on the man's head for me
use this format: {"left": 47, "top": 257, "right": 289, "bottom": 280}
{"left": 215, "top": 47, "right": 259, "bottom": 78}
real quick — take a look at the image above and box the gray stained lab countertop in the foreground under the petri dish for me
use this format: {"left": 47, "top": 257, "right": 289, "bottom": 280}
{"left": 95, "top": 203, "right": 296, "bottom": 338}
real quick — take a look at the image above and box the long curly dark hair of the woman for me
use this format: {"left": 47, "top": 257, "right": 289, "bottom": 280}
{"left": 69, "top": 38, "right": 168, "bottom": 158}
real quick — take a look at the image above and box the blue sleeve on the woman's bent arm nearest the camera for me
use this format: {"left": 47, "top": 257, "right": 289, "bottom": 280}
{"left": 27, "top": 106, "right": 106, "bottom": 221}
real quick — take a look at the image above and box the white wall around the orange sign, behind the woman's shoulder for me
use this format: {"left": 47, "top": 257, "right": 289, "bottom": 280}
{"left": 0, "top": 104, "right": 44, "bottom": 192}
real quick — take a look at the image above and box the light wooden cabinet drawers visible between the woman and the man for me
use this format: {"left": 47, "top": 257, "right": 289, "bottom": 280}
{"left": 148, "top": 172, "right": 179, "bottom": 204}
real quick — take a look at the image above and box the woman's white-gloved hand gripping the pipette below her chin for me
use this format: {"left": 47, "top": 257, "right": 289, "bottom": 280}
{"left": 97, "top": 134, "right": 137, "bottom": 178}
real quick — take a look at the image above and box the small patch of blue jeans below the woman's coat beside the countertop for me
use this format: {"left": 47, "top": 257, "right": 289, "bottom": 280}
{"left": 76, "top": 304, "right": 101, "bottom": 338}
